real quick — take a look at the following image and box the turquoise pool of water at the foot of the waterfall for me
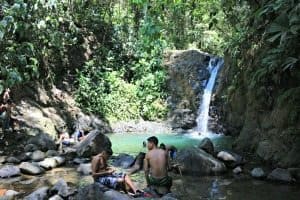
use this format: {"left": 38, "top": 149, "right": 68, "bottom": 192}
{"left": 108, "top": 133, "right": 232, "bottom": 154}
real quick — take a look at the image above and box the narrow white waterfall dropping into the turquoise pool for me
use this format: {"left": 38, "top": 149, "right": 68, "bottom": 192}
{"left": 196, "top": 58, "right": 223, "bottom": 137}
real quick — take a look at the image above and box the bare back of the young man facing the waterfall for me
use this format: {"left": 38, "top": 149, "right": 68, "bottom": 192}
{"left": 145, "top": 149, "right": 168, "bottom": 178}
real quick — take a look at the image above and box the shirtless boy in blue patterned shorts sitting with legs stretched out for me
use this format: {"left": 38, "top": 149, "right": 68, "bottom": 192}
{"left": 92, "top": 151, "right": 140, "bottom": 194}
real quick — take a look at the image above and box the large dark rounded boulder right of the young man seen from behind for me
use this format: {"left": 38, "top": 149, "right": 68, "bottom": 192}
{"left": 176, "top": 148, "right": 226, "bottom": 175}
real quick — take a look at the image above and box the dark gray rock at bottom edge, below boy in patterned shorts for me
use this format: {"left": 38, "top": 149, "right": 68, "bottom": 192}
{"left": 75, "top": 183, "right": 104, "bottom": 200}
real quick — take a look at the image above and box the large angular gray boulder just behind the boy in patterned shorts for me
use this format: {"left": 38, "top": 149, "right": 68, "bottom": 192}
{"left": 75, "top": 129, "right": 112, "bottom": 157}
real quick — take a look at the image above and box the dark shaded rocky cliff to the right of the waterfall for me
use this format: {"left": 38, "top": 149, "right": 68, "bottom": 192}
{"left": 213, "top": 56, "right": 300, "bottom": 167}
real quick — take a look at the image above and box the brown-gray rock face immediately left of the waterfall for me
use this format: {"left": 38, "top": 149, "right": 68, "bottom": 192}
{"left": 165, "top": 50, "right": 210, "bottom": 129}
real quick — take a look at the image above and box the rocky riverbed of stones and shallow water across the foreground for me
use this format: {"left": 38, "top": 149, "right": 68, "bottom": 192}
{"left": 0, "top": 131, "right": 300, "bottom": 200}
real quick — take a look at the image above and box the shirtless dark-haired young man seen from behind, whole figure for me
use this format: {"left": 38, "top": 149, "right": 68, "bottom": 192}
{"left": 144, "top": 136, "right": 172, "bottom": 192}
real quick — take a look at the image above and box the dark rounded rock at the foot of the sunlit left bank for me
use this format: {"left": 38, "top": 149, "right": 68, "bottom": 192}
{"left": 27, "top": 133, "right": 56, "bottom": 151}
